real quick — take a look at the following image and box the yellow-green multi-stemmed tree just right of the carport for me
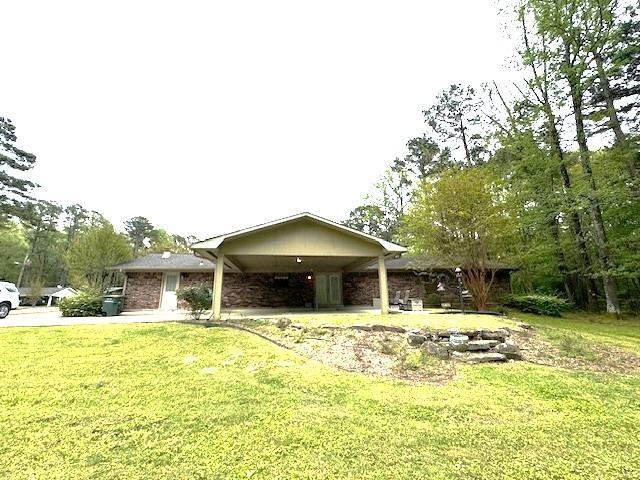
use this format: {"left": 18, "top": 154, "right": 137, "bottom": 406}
{"left": 403, "top": 168, "right": 511, "bottom": 310}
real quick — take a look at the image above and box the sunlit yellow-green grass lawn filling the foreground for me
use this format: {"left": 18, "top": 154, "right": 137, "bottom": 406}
{"left": 0, "top": 318, "right": 640, "bottom": 479}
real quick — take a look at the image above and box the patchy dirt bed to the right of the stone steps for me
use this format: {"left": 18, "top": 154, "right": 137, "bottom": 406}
{"left": 511, "top": 329, "right": 640, "bottom": 374}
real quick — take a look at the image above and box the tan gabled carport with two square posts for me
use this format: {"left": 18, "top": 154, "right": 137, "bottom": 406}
{"left": 191, "top": 213, "right": 407, "bottom": 320}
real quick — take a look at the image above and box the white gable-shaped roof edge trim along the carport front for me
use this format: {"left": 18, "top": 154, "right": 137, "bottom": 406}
{"left": 191, "top": 212, "right": 407, "bottom": 253}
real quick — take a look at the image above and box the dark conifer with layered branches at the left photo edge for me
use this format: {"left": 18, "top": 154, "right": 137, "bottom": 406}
{"left": 0, "top": 117, "right": 36, "bottom": 222}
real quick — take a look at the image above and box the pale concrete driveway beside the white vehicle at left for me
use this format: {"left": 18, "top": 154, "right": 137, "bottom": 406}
{"left": 0, "top": 307, "right": 187, "bottom": 327}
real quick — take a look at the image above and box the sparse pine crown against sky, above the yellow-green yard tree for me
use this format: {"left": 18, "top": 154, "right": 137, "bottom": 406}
{"left": 422, "top": 84, "right": 486, "bottom": 166}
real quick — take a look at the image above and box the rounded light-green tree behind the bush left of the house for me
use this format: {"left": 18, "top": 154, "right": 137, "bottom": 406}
{"left": 66, "top": 224, "right": 131, "bottom": 291}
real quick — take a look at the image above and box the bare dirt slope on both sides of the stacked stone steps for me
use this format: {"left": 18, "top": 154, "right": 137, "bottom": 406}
{"left": 204, "top": 319, "right": 640, "bottom": 385}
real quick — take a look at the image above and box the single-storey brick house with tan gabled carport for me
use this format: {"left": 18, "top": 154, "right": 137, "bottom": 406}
{"left": 110, "top": 213, "right": 509, "bottom": 317}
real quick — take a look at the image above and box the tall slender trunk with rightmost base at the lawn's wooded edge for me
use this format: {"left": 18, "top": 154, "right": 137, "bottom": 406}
{"left": 565, "top": 52, "right": 620, "bottom": 315}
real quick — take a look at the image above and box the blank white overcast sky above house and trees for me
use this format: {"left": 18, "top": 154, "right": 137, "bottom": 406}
{"left": 0, "top": 0, "right": 512, "bottom": 238}
